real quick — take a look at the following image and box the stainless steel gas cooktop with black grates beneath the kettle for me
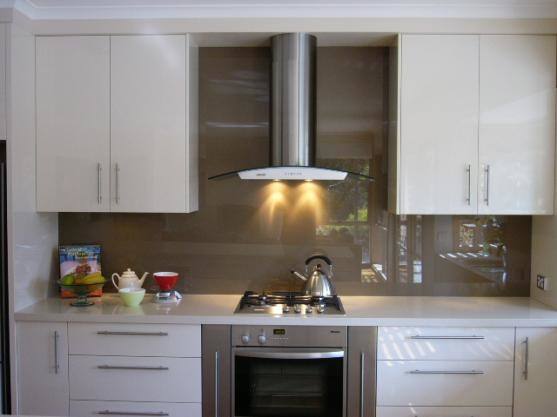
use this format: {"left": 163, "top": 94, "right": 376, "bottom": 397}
{"left": 235, "top": 291, "right": 344, "bottom": 315}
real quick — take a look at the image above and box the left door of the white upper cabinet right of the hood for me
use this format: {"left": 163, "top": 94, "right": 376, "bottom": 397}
{"left": 397, "top": 35, "right": 479, "bottom": 214}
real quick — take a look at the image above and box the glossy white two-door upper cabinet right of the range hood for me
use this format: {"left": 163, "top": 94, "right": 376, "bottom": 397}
{"left": 389, "top": 35, "right": 557, "bottom": 215}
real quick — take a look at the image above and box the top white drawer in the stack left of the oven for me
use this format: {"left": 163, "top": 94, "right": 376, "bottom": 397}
{"left": 69, "top": 323, "right": 201, "bottom": 358}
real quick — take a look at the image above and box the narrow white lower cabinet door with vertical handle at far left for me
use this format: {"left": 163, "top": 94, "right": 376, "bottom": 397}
{"left": 16, "top": 322, "right": 70, "bottom": 416}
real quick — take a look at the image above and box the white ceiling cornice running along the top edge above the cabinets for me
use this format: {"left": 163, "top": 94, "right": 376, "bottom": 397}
{"left": 9, "top": 0, "right": 557, "bottom": 20}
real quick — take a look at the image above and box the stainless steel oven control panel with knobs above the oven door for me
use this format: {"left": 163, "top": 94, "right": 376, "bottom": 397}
{"left": 232, "top": 326, "right": 347, "bottom": 347}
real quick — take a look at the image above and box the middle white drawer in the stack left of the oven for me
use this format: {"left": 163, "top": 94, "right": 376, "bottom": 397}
{"left": 70, "top": 356, "right": 201, "bottom": 402}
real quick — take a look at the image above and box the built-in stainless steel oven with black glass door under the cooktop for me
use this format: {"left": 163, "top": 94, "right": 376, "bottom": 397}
{"left": 232, "top": 326, "right": 347, "bottom": 417}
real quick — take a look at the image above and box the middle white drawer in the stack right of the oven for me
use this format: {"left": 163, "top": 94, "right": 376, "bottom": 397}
{"left": 377, "top": 361, "right": 513, "bottom": 406}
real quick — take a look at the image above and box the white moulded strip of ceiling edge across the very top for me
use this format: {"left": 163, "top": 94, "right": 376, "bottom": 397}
{"left": 8, "top": 0, "right": 557, "bottom": 19}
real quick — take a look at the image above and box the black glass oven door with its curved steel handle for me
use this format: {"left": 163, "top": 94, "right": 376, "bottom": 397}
{"left": 233, "top": 348, "right": 346, "bottom": 417}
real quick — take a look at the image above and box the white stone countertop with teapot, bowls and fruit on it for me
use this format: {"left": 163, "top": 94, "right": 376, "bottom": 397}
{"left": 11, "top": 294, "right": 557, "bottom": 327}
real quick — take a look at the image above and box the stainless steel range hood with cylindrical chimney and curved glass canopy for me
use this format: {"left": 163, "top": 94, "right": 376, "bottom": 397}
{"left": 209, "top": 33, "right": 373, "bottom": 181}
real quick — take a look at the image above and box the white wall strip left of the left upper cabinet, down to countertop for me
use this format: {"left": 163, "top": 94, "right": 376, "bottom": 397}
{"left": 7, "top": 15, "right": 58, "bottom": 310}
